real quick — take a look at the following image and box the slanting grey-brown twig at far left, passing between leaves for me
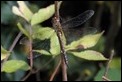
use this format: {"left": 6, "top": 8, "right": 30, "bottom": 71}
{"left": 1, "top": 32, "right": 22, "bottom": 68}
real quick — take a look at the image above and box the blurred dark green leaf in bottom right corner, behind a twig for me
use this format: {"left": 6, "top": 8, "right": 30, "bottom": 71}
{"left": 95, "top": 68, "right": 121, "bottom": 81}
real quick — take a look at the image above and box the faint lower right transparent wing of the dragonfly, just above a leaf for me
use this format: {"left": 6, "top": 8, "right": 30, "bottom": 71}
{"left": 63, "top": 27, "right": 97, "bottom": 44}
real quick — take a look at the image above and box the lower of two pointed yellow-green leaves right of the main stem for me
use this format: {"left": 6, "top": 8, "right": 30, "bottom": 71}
{"left": 69, "top": 50, "right": 107, "bottom": 61}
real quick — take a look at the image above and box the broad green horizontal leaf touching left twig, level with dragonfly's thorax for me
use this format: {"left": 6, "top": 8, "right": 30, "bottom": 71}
{"left": 32, "top": 26, "right": 54, "bottom": 40}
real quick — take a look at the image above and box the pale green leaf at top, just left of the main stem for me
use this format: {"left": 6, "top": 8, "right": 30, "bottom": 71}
{"left": 31, "top": 5, "right": 54, "bottom": 25}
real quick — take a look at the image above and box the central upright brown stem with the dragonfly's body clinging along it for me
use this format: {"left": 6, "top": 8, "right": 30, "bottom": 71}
{"left": 53, "top": 1, "right": 68, "bottom": 81}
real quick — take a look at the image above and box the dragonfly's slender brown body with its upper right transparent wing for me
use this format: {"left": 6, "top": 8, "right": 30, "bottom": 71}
{"left": 53, "top": 10, "right": 94, "bottom": 66}
